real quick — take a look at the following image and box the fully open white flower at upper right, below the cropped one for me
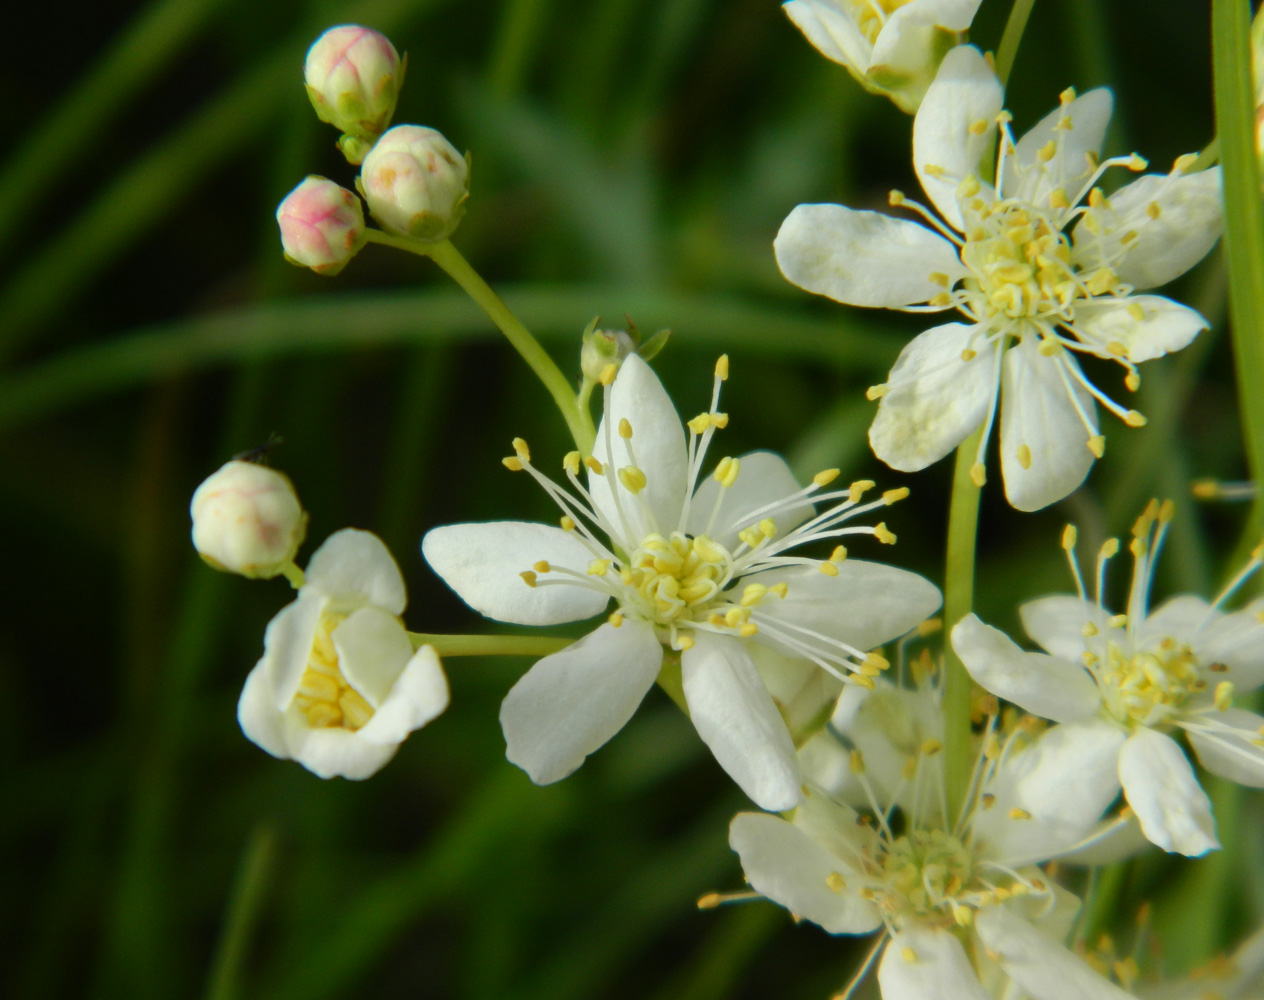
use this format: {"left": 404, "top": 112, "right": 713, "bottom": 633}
{"left": 775, "top": 46, "right": 1222, "bottom": 511}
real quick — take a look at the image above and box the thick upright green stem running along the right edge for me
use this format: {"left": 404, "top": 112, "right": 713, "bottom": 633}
{"left": 1211, "top": 0, "right": 1264, "bottom": 571}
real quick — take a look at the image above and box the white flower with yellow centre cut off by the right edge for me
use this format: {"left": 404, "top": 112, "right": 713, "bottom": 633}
{"left": 952, "top": 504, "right": 1264, "bottom": 856}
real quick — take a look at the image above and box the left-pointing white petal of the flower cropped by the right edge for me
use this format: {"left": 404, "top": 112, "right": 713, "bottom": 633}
{"left": 952, "top": 614, "right": 1101, "bottom": 722}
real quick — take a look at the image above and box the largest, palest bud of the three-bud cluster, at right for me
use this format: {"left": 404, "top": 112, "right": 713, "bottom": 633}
{"left": 360, "top": 125, "right": 469, "bottom": 243}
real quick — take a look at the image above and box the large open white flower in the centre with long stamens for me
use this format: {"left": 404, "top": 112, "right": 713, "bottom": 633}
{"left": 422, "top": 355, "right": 939, "bottom": 809}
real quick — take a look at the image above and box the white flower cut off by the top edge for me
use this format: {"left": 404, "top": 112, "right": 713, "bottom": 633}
{"left": 782, "top": 0, "right": 980, "bottom": 113}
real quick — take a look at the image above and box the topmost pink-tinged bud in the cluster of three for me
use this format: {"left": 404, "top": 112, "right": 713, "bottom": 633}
{"left": 303, "top": 24, "right": 406, "bottom": 156}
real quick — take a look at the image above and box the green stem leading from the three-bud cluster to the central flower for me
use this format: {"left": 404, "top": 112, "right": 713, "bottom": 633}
{"left": 368, "top": 229, "right": 595, "bottom": 455}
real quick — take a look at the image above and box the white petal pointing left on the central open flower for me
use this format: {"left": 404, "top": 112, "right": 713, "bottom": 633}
{"left": 421, "top": 521, "right": 611, "bottom": 625}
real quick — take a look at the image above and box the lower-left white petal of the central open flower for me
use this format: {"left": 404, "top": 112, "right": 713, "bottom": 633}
{"left": 501, "top": 619, "right": 662, "bottom": 785}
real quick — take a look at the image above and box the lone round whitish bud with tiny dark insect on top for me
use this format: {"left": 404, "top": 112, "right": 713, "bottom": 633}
{"left": 188, "top": 460, "right": 307, "bottom": 579}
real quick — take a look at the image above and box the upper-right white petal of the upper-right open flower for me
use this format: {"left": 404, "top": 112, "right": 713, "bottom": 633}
{"left": 1072, "top": 167, "right": 1225, "bottom": 288}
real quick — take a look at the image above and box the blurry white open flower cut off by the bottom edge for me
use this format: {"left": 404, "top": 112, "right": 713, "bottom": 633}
{"left": 729, "top": 681, "right": 1126, "bottom": 1000}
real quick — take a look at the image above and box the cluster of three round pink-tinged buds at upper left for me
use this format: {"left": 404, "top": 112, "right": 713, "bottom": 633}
{"left": 277, "top": 24, "right": 469, "bottom": 274}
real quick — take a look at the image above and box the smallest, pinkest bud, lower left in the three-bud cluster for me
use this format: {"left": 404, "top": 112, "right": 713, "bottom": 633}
{"left": 277, "top": 174, "right": 364, "bottom": 274}
